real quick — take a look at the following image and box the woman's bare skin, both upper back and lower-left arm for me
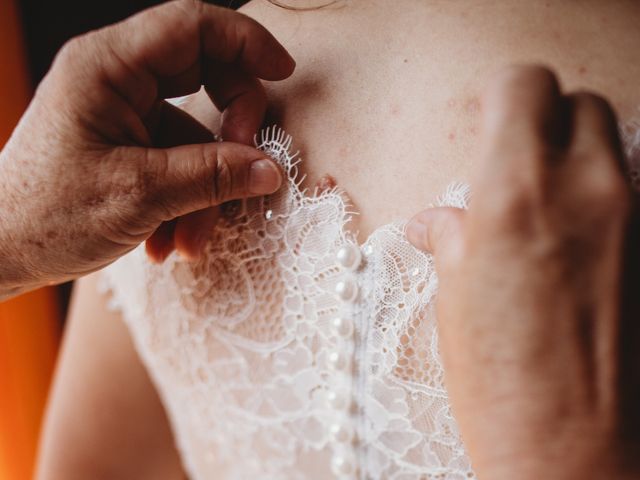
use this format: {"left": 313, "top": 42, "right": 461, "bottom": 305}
{"left": 37, "top": 0, "right": 640, "bottom": 479}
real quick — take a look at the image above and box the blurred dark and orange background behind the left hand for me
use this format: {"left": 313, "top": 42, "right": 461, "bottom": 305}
{"left": 0, "top": 0, "right": 246, "bottom": 480}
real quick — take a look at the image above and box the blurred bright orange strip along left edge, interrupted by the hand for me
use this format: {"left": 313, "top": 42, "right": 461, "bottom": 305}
{"left": 0, "top": 0, "right": 60, "bottom": 480}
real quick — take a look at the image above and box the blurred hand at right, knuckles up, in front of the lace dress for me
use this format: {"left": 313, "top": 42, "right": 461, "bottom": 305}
{"left": 407, "top": 67, "right": 640, "bottom": 480}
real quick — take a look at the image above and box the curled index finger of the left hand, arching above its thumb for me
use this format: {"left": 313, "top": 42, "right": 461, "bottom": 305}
{"left": 77, "top": 0, "right": 295, "bottom": 117}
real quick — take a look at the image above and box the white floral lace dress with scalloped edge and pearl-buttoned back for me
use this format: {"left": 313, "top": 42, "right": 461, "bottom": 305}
{"left": 103, "top": 122, "right": 638, "bottom": 480}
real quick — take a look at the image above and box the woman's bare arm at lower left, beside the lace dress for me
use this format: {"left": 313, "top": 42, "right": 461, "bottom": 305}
{"left": 37, "top": 274, "right": 184, "bottom": 480}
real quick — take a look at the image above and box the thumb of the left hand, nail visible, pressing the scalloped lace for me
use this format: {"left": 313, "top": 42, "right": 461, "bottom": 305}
{"left": 134, "top": 142, "right": 282, "bottom": 220}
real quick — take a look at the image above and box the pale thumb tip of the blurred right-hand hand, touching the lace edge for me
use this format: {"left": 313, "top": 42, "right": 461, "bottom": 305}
{"left": 406, "top": 207, "right": 465, "bottom": 259}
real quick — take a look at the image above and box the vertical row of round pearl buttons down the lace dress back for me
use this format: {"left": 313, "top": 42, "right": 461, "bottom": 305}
{"left": 327, "top": 244, "right": 362, "bottom": 478}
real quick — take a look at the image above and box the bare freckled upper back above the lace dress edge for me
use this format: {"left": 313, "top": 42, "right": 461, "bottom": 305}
{"left": 236, "top": 0, "right": 640, "bottom": 239}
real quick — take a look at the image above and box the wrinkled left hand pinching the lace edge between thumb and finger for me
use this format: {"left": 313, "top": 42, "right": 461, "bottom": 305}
{"left": 0, "top": 0, "right": 295, "bottom": 298}
